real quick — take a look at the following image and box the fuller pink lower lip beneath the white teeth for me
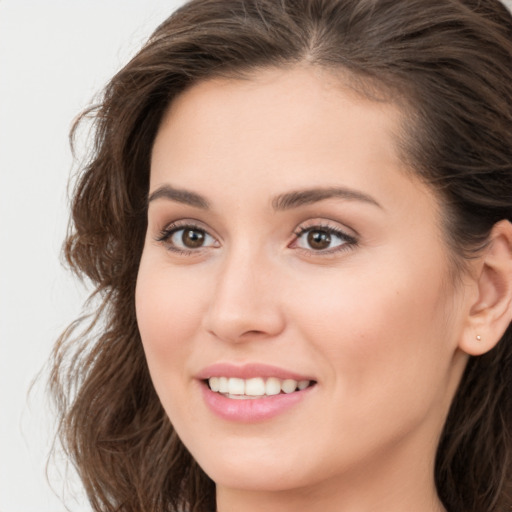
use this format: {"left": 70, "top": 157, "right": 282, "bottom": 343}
{"left": 201, "top": 382, "right": 314, "bottom": 423}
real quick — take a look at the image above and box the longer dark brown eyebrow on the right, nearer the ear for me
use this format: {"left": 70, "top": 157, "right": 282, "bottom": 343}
{"left": 272, "top": 187, "right": 382, "bottom": 211}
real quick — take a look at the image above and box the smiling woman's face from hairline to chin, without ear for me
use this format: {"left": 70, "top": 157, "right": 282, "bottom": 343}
{"left": 136, "top": 68, "right": 472, "bottom": 500}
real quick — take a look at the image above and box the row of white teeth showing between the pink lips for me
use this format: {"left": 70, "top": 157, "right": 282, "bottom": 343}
{"left": 205, "top": 377, "right": 315, "bottom": 400}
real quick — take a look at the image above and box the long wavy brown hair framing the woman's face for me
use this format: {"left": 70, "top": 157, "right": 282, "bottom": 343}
{"left": 50, "top": 0, "right": 512, "bottom": 512}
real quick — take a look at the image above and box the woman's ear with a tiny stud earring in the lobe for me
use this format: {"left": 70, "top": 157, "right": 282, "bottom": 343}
{"left": 459, "top": 220, "right": 512, "bottom": 356}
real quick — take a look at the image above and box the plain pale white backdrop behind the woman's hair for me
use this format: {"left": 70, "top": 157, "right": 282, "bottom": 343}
{"left": 0, "top": 0, "right": 512, "bottom": 512}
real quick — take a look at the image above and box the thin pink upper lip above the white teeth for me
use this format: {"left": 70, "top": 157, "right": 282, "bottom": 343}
{"left": 196, "top": 363, "right": 315, "bottom": 381}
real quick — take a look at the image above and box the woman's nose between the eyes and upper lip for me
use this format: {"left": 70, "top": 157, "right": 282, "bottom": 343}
{"left": 203, "top": 245, "right": 285, "bottom": 343}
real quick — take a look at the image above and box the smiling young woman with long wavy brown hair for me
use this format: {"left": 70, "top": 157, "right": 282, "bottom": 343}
{"left": 52, "top": 0, "right": 512, "bottom": 512}
